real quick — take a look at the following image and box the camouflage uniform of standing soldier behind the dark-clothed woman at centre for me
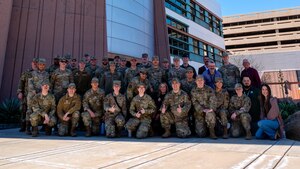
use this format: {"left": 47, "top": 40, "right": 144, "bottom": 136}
{"left": 148, "top": 67, "right": 166, "bottom": 95}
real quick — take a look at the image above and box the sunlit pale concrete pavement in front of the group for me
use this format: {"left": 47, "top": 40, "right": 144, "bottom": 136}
{"left": 0, "top": 129, "right": 300, "bottom": 169}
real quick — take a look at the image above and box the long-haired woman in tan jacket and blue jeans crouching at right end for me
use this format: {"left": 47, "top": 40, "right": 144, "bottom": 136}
{"left": 255, "top": 84, "right": 283, "bottom": 140}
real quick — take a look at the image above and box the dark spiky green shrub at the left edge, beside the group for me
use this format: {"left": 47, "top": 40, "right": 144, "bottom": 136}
{"left": 0, "top": 98, "right": 21, "bottom": 123}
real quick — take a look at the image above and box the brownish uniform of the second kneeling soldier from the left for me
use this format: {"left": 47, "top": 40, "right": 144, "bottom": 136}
{"left": 57, "top": 93, "right": 81, "bottom": 136}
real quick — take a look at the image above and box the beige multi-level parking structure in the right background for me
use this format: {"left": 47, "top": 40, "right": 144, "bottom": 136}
{"left": 223, "top": 7, "right": 300, "bottom": 99}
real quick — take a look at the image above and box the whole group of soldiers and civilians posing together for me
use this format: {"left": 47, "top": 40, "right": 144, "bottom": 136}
{"left": 17, "top": 54, "right": 282, "bottom": 139}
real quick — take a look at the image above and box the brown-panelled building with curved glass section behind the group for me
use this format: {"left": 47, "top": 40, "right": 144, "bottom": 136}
{"left": 0, "top": 0, "right": 225, "bottom": 100}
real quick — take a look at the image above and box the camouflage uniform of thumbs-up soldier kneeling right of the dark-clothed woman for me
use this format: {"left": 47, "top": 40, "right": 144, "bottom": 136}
{"left": 160, "top": 90, "right": 191, "bottom": 138}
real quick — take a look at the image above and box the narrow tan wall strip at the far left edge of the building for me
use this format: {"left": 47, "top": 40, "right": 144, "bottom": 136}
{"left": 0, "top": 0, "right": 13, "bottom": 92}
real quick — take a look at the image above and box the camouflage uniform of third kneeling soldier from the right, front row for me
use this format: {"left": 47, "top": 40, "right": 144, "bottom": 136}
{"left": 191, "top": 85, "right": 217, "bottom": 137}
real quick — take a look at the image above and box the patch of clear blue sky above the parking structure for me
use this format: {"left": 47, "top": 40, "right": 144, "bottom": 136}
{"left": 217, "top": 0, "right": 300, "bottom": 16}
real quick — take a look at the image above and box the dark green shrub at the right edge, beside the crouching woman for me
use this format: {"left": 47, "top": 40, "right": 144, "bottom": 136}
{"left": 278, "top": 99, "right": 300, "bottom": 120}
